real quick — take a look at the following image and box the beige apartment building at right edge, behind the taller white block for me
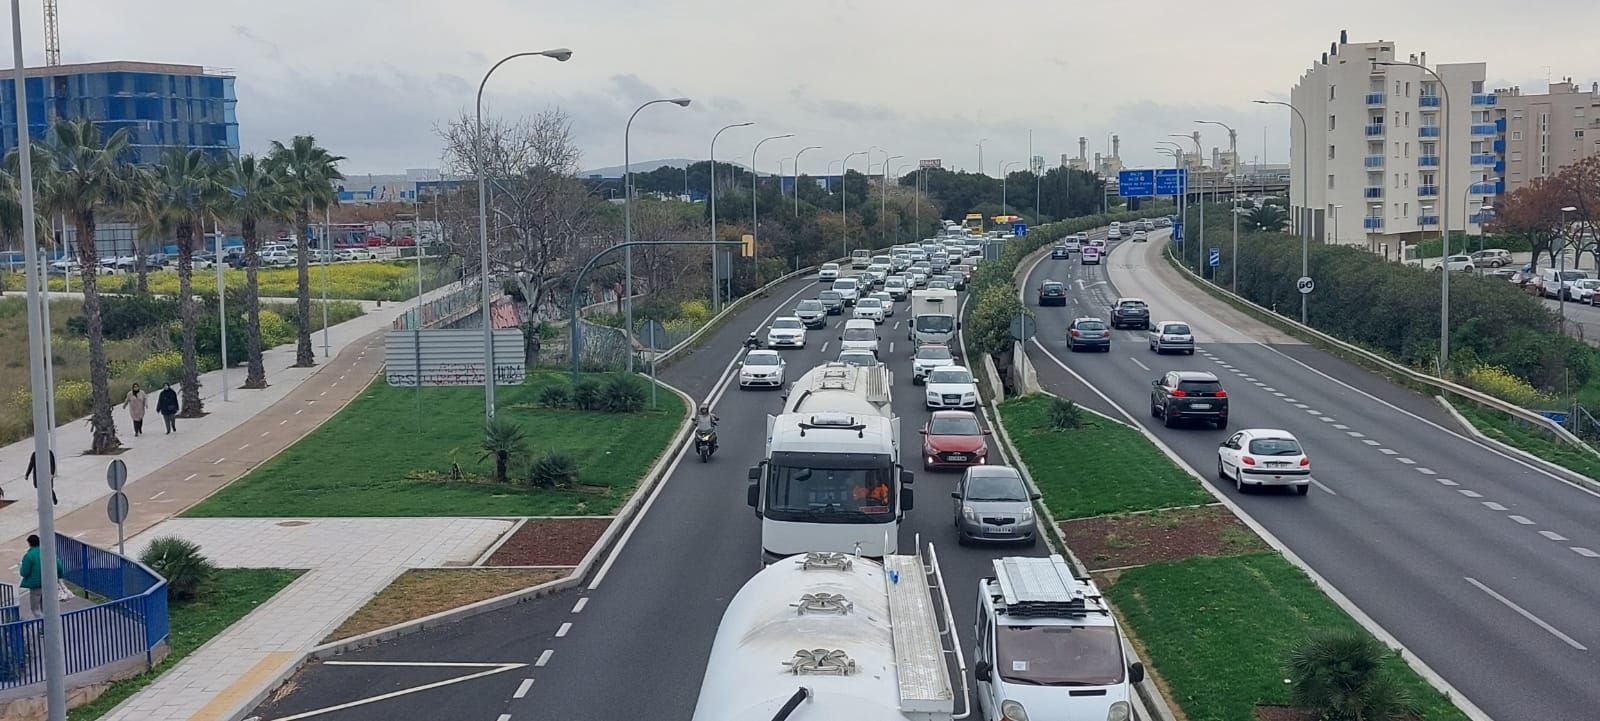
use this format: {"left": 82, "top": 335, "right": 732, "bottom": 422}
{"left": 1493, "top": 78, "right": 1600, "bottom": 192}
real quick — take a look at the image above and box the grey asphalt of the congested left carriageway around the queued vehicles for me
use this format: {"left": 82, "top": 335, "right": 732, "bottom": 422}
{"left": 254, "top": 262, "right": 1045, "bottom": 721}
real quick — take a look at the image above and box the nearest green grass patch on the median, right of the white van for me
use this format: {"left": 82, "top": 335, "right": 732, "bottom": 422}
{"left": 1106, "top": 553, "right": 1466, "bottom": 721}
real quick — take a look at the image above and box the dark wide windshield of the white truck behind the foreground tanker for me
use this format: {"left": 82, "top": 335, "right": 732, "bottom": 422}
{"left": 763, "top": 452, "right": 896, "bottom": 523}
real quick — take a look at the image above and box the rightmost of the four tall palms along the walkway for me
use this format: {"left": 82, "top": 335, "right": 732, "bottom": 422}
{"left": 267, "top": 136, "right": 344, "bottom": 368}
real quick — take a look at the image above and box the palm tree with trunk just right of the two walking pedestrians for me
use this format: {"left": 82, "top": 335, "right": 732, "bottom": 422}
{"left": 139, "top": 147, "right": 227, "bottom": 417}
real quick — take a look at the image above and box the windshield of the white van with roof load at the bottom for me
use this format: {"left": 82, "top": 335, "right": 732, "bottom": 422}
{"left": 995, "top": 625, "right": 1125, "bottom": 686}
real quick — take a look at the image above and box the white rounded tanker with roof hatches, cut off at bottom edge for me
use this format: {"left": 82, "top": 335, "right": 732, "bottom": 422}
{"left": 693, "top": 544, "right": 971, "bottom": 721}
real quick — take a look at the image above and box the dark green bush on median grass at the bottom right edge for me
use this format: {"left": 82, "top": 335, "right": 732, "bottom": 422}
{"left": 1288, "top": 631, "right": 1413, "bottom": 721}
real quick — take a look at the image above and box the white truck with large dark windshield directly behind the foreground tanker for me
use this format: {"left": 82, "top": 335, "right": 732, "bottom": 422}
{"left": 746, "top": 363, "right": 914, "bottom": 563}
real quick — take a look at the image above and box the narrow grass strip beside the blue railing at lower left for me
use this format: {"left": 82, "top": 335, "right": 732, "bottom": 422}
{"left": 67, "top": 568, "right": 301, "bottom": 721}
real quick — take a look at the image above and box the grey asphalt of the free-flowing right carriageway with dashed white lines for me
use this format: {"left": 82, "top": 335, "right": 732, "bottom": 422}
{"left": 1022, "top": 233, "right": 1600, "bottom": 721}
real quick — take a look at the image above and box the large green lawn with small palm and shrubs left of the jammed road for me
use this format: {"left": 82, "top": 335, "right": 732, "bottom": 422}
{"left": 186, "top": 372, "right": 685, "bottom": 518}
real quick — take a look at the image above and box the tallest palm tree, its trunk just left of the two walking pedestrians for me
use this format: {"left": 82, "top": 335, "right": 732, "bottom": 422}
{"left": 38, "top": 120, "right": 133, "bottom": 454}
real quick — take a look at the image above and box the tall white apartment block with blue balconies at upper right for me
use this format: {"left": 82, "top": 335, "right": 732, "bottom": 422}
{"left": 1290, "top": 37, "right": 1498, "bottom": 257}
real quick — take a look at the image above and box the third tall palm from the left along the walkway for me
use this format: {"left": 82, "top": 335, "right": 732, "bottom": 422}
{"left": 222, "top": 155, "right": 299, "bottom": 388}
